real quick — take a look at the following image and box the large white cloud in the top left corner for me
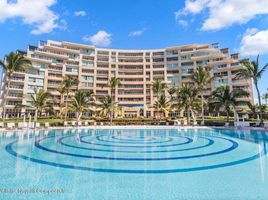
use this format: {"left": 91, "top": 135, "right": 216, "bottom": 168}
{"left": 0, "top": 0, "right": 59, "bottom": 35}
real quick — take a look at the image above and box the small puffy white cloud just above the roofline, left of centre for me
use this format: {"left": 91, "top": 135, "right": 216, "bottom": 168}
{"left": 83, "top": 31, "right": 112, "bottom": 47}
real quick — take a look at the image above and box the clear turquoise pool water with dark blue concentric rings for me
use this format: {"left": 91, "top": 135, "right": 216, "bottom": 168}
{"left": 0, "top": 128, "right": 268, "bottom": 200}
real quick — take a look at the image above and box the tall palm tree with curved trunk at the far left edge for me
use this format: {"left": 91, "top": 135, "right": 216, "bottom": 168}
{"left": 0, "top": 52, "right": 32, "bottom": 120}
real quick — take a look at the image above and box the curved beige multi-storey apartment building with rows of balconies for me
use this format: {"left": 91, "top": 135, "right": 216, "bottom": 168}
{"left": 1, "top": 40, "right": 253, "bottom": 117}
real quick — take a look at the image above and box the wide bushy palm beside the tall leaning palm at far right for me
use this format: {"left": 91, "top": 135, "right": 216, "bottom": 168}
{"left": 210, "top": 86, "right": 249, "bottom": 123}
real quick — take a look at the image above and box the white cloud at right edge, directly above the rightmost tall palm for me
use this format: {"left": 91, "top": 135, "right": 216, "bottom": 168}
{"left": 240, "top": 28, "right": 268, "bottom": 56}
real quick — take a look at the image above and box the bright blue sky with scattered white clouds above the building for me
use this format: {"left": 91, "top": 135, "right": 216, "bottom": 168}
{"left": 0, "top": 0, "right": 268, "bottom": 98}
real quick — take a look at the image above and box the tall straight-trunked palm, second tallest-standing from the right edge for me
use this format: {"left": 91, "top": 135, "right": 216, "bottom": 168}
{"left": 191, "top": 66, "right": 214, "bottom": 125}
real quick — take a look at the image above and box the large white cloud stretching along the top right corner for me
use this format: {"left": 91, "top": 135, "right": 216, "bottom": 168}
{"left": 175, "top": 0, "right": 268, "bottom": 31}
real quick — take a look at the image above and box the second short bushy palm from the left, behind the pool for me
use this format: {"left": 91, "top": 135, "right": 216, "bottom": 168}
{"left": 70, "top": 90, "right": 94, "bottom": 123}
